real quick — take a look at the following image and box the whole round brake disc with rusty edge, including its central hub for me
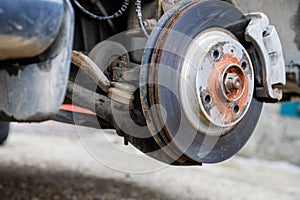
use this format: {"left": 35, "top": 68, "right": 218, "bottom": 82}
{"left": 140, "top": 1, "right": 262, "bottom": 164}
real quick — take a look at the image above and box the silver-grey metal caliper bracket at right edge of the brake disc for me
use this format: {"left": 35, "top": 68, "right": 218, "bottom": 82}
{"left": 245, "top": 13, "right": 286, "bottom": 102}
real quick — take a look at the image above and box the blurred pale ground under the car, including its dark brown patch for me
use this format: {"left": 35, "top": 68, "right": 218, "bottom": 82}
{"left": 0, "top": 117, "right": 300, "bottom": 200}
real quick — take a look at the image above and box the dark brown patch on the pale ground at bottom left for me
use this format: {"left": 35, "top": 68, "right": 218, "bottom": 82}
{"left": 0, "top": 164, "right": 169, "bottom": 200}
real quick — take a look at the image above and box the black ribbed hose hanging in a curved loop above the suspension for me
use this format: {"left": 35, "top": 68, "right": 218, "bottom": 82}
{"left": 73, "top": 0, "right": 130, "bottom": 21}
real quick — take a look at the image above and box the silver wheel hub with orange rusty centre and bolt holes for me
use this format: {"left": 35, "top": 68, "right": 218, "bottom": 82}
{"left": 180, "top": 29, "right": 254, "bottom": 135}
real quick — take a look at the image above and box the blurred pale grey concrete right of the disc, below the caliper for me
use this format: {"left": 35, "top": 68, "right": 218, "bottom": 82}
{"left": 240, "top": 104, "right": 300, "bottom": 166}
